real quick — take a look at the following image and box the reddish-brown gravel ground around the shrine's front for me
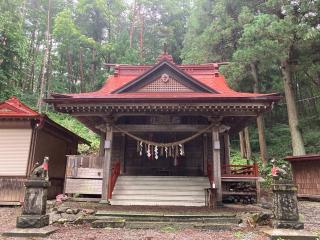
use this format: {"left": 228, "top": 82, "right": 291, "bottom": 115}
{"left": 0, "top": 202, "right": 320, "bottom": 240}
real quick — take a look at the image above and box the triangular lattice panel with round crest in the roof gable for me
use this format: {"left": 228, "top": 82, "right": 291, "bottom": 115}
{"left": 138, "top": 74, "right": 194, "bottom": 92}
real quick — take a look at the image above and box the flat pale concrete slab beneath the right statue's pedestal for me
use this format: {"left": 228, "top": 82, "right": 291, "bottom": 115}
{"left": 262, "top": 229, "right": 317, "bottom": 240}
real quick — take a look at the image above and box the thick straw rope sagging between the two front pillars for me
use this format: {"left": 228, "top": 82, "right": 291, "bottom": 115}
{"left": 114, "top": 123, "right": 214, "bottom": 147}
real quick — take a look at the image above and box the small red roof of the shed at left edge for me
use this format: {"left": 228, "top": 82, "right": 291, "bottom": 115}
{"left": 0, "top": 97, "right": 40, "bottom": 118}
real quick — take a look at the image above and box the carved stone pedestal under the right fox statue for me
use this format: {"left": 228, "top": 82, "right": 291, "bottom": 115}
{"left": 272, "top": 179, "right": 304, "bottom": 229}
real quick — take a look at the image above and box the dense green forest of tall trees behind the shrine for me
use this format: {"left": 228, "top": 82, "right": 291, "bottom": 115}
{"left": 0, "top": 0, "right": 320, "bottom": 169}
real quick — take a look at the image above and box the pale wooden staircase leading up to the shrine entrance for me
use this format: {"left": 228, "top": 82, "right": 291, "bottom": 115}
{"left": 110, "top": 176, "right": 209, "bottom": 206}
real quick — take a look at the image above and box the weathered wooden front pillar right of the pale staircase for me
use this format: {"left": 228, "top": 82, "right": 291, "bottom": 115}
{"left": 212, "top": 127, "right": 222, "bottom": 206}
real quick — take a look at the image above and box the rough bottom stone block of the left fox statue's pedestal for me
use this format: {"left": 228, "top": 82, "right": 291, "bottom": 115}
{"left": 16, "top": 215, "right": 49, "bottom": 228}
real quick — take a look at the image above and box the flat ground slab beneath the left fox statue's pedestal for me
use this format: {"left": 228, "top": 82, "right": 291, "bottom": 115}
{"left": 2, "top": 226, "right": 58, "bottom": 238}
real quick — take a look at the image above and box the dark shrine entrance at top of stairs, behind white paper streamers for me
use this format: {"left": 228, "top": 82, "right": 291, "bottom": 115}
{"left": 122, "top": 132, "right": 205, "bottom": 176}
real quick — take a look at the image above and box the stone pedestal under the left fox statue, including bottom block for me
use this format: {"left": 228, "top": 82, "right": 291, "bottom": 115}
{"left": 16, "top": 179, "right": 50, "bottom": 228}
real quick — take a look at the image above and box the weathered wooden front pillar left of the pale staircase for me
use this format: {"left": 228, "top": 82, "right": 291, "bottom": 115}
{"left": 101, "top": 118, "right": 113, "bottom": 203}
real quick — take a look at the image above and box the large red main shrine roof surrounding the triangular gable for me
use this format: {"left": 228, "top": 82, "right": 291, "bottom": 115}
{"left": 49, "top": 53, "right": 279, "bottom": 101}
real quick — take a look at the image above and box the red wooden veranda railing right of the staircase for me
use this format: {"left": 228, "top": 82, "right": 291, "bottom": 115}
{"left": 221, "top": 164, "right": 259, "bottom": 177}
